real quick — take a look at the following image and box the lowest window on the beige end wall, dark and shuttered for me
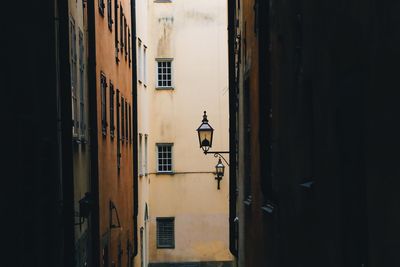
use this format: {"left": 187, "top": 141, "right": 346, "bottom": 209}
{"left": 157, "top": 218, "right": 175, "bottom": 248}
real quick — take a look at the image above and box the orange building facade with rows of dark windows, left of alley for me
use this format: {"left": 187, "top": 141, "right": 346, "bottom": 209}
{"left": 94, "top": 0, "right": 134, "bottom": 266}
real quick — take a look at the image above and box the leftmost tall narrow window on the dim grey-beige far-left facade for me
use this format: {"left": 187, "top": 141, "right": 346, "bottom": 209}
{"left": 69, "top": 18, "right": 79, "bottom": 138}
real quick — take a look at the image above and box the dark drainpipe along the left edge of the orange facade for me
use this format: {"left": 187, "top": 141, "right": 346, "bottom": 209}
{"left": 86, "top": 1, "right": 100, "bottom": 266}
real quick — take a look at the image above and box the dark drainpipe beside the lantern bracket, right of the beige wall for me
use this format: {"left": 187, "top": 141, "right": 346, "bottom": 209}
{"left": 228, "top": 0, "right": 238, "bottom": 257}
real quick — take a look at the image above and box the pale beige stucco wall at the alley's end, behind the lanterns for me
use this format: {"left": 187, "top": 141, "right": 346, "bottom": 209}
{"left": 145, "top": 0, "right": 232, "bottom": 262}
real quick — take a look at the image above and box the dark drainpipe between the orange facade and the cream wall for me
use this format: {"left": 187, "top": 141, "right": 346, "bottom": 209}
{"left": 131, "top": 0, "right": 139, "bottom": 257}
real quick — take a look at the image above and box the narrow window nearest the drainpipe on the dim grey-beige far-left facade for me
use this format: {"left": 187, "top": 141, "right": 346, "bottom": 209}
{"left": 79, "top": 30, "right": 86, "bottom": 139}
